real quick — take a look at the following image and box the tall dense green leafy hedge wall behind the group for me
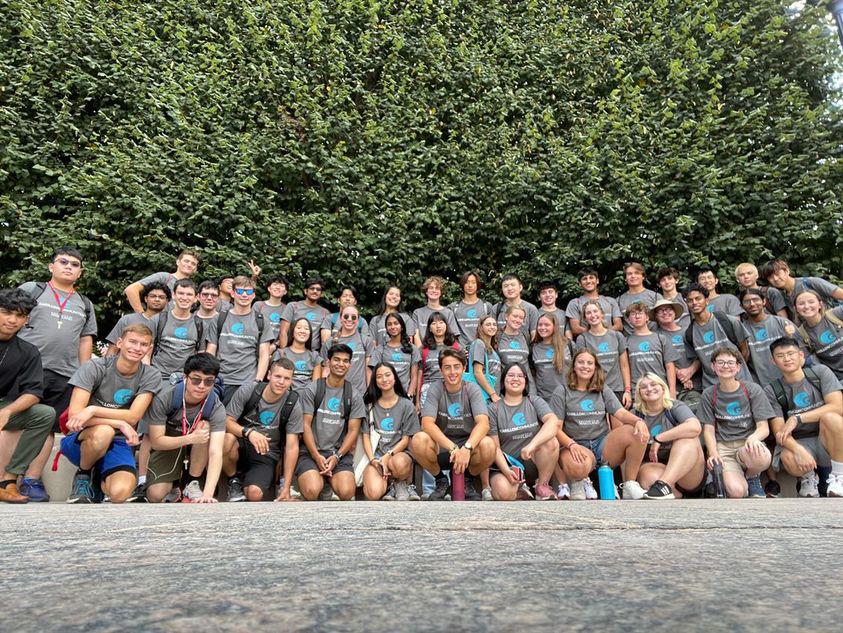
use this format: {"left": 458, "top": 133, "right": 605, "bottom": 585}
{"left": 0, "top": 0, "right": 843, "bottom": 322}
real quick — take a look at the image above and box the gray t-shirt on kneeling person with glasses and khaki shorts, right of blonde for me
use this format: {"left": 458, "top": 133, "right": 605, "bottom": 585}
{"left": 699, "top": 382, "right": 775, "bottom": 442}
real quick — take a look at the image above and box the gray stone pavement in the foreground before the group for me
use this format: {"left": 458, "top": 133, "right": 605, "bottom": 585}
{"left": 0, "top": 499, "right": 843, "bottom": 633}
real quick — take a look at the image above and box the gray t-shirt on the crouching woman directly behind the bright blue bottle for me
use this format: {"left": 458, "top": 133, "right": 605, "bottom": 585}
{"left": 550, "top": 384, "right": 623, "bottom": 440}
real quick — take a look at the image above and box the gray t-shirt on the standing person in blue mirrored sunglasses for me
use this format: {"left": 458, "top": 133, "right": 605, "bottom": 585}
{"left": 211, "top": 310, "right": 273, "bottom": 386}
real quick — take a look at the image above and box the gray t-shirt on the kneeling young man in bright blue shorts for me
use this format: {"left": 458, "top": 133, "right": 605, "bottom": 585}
{"left": 68, "top": 356, "right": 163, "bottom": 422}
